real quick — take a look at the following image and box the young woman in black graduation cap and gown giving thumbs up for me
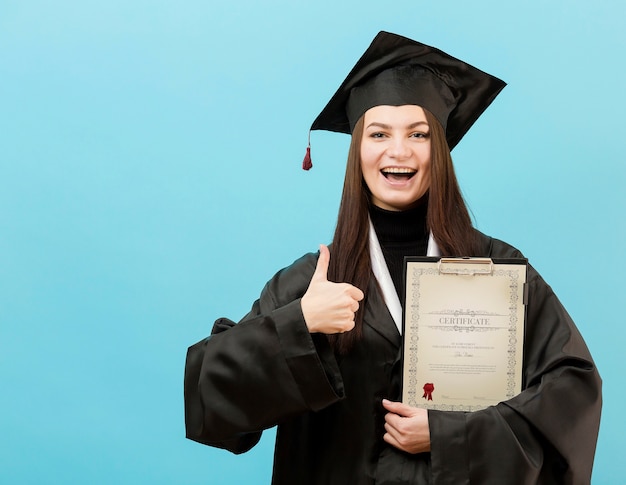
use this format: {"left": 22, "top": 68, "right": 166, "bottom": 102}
{"left": 185, "top": 32, "right": 601, "bottom": 485}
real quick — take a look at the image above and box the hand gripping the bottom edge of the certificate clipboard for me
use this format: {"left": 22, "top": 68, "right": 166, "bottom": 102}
{"left": 383, "top": 399, "right": 430, "bottom": 454}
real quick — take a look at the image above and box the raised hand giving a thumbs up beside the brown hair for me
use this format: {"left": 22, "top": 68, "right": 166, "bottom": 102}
{"left": 301, "top": 244, "right": 364, "bottom": 334}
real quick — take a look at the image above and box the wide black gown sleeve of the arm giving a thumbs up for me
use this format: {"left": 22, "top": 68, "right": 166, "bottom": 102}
{"left": 184, "top": 253, "right": 344, "bottom": 453}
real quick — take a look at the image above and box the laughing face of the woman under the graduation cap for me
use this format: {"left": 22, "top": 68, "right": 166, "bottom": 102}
{"left": 361, "top": 105, "right": 430, "bottom": 211}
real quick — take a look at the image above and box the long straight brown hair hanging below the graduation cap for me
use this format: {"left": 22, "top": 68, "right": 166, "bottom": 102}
{"left": 328, "top": 110, "right": 477, "bottom": 354}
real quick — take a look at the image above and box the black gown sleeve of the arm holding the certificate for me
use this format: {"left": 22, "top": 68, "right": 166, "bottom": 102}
{"left": 429, "top": 267, "right": 602, "bottom": 485}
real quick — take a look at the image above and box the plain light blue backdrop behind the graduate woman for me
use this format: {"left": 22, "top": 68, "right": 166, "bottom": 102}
{"left": 0, "top": 0, "right": 626, "bottom": 484}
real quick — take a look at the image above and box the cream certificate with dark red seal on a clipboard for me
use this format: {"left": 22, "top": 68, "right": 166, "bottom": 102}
{"left": 402, "top": 258, "right": 526, "bottom": 411}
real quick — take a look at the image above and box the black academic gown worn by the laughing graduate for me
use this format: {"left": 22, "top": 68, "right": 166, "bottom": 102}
{"left": 185, "top": 234, "right": 601, "bottom": 485}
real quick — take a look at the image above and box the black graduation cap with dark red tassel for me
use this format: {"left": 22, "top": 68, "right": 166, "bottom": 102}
{"left": 302, "top": 32, "right": 506, "bottom": 170}
